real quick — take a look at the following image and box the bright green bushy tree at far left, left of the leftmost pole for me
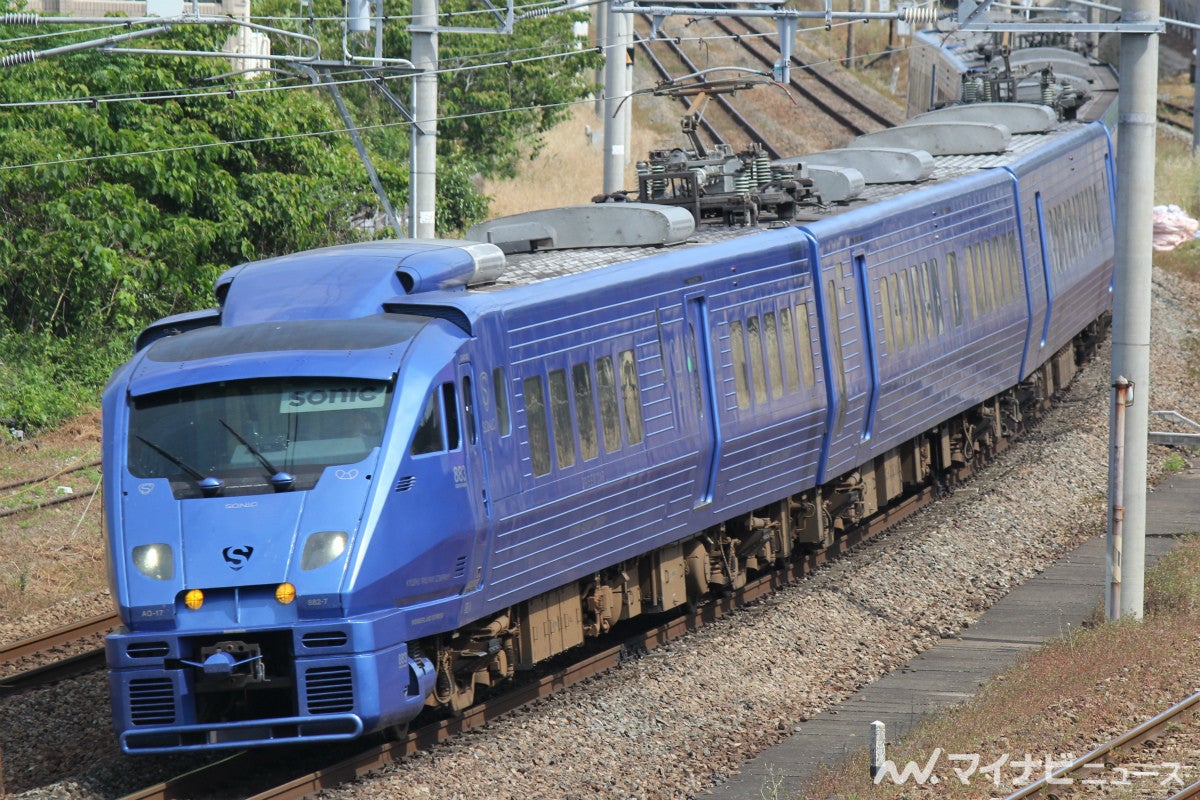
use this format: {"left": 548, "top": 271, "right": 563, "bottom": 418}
{"left": 0, "top": 18, "right": 388, "bottom": 426}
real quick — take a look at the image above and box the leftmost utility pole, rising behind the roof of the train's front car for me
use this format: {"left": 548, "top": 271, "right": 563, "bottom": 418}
{"left": 408, "top": 0, "right": 438, "bottom": 239}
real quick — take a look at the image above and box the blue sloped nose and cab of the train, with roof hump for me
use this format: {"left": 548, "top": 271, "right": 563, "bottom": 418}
{"left": 103, "top": 242, "right": 503, "bottom": 753}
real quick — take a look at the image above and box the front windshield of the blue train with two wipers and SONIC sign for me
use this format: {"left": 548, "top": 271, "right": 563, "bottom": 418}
{"left": 128, "top": 378, "right": 391, "bottom": 498}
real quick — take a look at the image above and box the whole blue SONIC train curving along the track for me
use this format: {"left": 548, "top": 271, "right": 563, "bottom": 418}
{"left": 103, "top": 29, "right": 1115, "bottom": 753}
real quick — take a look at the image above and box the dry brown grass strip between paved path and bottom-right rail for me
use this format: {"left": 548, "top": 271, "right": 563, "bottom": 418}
{"left": 799, "top": 537, "right": 1200, "bottom": 800}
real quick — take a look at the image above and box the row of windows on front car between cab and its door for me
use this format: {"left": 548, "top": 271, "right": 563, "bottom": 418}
{"left": 520, "top": 350, "right": 644, "bottom": 475}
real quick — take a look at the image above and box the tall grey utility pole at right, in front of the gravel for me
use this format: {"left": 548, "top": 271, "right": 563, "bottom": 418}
{"left": 1105, "top": 0, "right": 1158, "bottom": 619}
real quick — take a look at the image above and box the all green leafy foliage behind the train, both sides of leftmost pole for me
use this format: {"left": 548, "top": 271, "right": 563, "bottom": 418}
{"left": 0, "top": 0, "right": 594, "bottom": 427}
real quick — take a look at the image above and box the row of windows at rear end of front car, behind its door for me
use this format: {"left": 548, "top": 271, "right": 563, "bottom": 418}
{"left": 730, "top": 302, "right": 816, "bottom": 408}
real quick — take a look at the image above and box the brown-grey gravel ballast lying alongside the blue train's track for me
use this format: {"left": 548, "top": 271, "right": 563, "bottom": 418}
{"left": 0, "top": 272, "right": 1200, "bottom": 800}
